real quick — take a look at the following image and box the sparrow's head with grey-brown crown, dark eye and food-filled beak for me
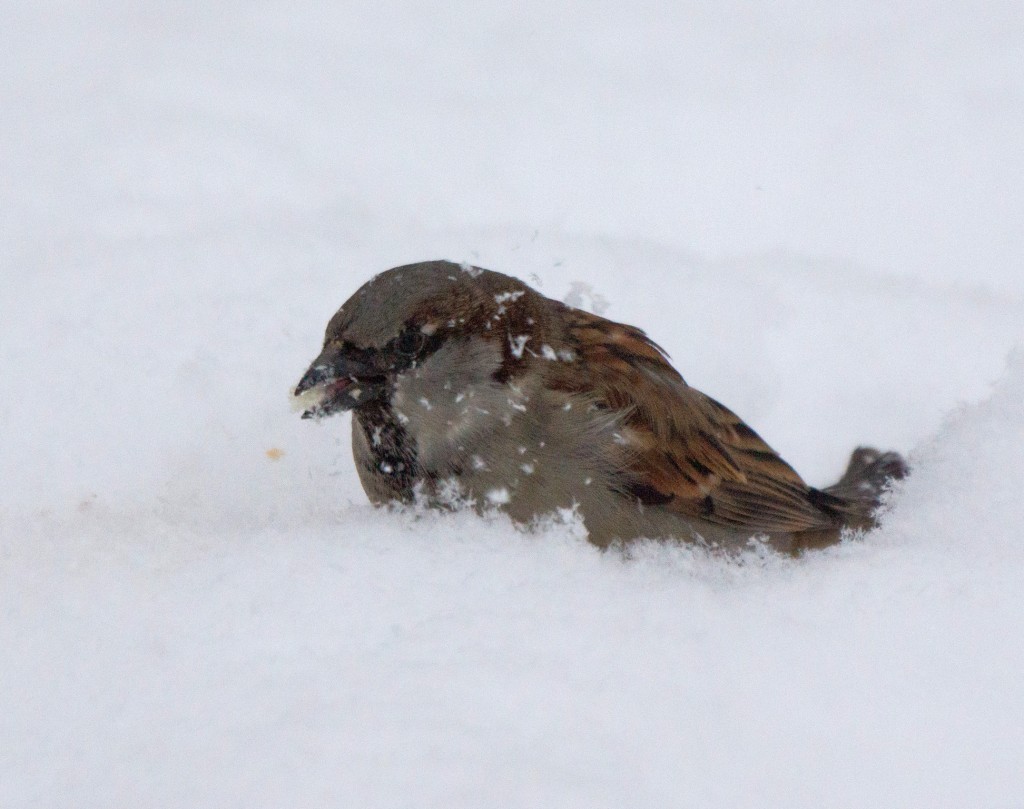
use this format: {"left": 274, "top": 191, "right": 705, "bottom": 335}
{"left": 294, "top": 261, "right": 536, "bottom": 419}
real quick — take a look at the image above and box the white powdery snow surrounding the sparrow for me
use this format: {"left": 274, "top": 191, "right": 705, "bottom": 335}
{"left": 0, "top": 0, "right": 1024, "bottom": 809}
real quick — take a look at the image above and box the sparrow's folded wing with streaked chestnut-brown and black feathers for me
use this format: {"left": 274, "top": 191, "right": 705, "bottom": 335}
{"left": 551, "top": 309, "right": 842, "bottom": 534}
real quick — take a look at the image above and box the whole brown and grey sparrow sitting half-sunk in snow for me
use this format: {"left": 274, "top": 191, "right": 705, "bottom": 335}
{"left": 295, "top": 261, "right": 906, "bottom": 552}
